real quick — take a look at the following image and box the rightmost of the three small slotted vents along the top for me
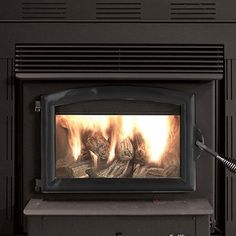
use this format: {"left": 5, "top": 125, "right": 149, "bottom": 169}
{"left": 170, "top": 1, "right": 216, "bottom": 20}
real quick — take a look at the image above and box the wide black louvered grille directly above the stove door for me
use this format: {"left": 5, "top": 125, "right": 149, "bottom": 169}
{"left": 15, "top": 45, "right": 224, "bottom": 73}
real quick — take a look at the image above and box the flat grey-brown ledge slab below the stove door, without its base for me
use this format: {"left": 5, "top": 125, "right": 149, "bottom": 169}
{"left": 24, "top": 199, "right": 213, "bottom": 216}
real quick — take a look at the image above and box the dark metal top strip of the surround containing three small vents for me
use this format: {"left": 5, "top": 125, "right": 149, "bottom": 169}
{"left": 0, "top": 0, "right": 236, "bottom": 22}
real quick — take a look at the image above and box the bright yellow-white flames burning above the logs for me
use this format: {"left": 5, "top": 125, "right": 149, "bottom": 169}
{"left": 56, "top": 115, "right": 179, "bottom": 163}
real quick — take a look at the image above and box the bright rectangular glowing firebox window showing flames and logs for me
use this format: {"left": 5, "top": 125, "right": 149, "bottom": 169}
{"left": 56, "top": 115, "right": 180, "bottom": 178}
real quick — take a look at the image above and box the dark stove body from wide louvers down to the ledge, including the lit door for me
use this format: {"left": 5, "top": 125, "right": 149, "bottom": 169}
{"left": 12, "top": 40, "right": 219, "bottom": 230}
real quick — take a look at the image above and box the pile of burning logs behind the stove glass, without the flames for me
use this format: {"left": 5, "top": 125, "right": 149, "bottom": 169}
{"left": 56, "top": 129, "right": 180, "bottom": 178}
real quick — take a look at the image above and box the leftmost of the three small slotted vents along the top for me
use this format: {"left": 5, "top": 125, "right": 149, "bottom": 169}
{"left": 22, "top": 2, "right": 67, "bottom": 20}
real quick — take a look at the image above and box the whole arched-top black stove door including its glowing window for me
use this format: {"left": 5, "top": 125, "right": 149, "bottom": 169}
{"left": 41, "top": 86, "right": 195, "bottom": 192}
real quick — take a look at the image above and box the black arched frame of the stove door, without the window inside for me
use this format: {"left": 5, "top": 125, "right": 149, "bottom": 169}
{"left": 41, "top": 86, "right": 196, "bottom": 193}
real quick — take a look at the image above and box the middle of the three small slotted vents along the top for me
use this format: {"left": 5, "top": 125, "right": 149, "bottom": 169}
{"left": 96, "top": 2, "right": 142, "bottom": 20}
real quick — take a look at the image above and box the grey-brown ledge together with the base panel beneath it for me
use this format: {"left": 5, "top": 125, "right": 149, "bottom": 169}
{"left": 24, "top": 199, "right": 213, "bottom": 236}
